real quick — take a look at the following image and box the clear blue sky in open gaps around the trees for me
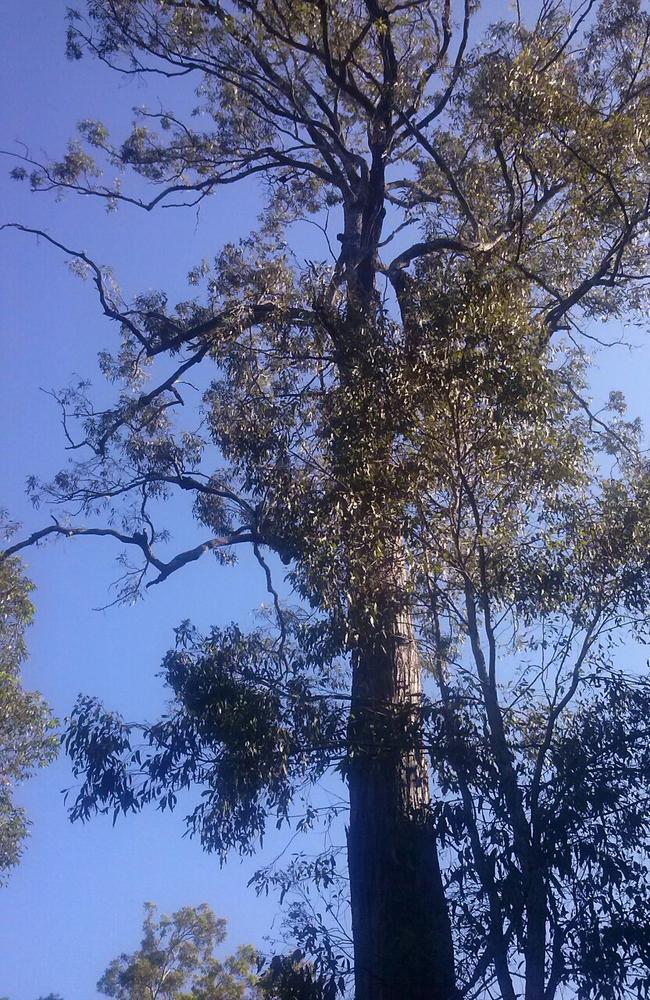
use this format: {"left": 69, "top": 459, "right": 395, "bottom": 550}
{"left": 0, "top": 0, "right": 648, "bottom": 1000}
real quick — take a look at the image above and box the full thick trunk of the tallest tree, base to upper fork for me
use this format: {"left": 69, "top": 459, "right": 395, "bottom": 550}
{"left": 334, "top": 156, "right": 456, "bottom": 1000}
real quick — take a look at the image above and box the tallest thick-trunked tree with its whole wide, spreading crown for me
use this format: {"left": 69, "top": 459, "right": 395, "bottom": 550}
{"left": 3, "top": 0, "right": 650, "bottom": 1000}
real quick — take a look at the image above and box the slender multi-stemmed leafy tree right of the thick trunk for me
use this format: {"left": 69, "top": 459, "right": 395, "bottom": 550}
{"left": 398, "top": 332, "right": 650, "bottom": 1000}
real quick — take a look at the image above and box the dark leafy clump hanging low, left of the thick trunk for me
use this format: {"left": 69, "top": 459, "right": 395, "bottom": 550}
{"left": 65, "top": 622, "right": 345, "bottom": 856}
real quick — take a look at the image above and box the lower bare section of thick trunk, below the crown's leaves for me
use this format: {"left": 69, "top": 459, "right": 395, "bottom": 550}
{"left": 348, "top": 604, "right": 456, "bottom": 1000}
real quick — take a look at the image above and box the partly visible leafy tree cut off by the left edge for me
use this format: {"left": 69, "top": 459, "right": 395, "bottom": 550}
{"left": 0, "top": 524, "right": 58, "bottom": 884}
